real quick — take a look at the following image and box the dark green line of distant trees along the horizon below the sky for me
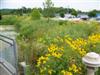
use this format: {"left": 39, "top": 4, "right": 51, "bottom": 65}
{"left": 0, "top": 0, "right": 100, "bottom": 17}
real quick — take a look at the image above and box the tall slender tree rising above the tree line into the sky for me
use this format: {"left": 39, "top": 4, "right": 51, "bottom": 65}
{"left": 43, "top": 0, "right": 54, "bottom": 22}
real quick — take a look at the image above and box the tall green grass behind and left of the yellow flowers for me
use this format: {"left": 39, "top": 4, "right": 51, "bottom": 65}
{"left": 0, "top": 16, "right": 100, "bottom": 74}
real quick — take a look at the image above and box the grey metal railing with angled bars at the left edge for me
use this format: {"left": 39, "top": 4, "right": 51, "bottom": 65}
{"left": 0, "top": 34, "right": 18, "bottom": 75}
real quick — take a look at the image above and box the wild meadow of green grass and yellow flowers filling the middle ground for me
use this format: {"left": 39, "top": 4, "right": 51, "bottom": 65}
{"left": 0, "top": 15, "right": 100, "bottom": 75}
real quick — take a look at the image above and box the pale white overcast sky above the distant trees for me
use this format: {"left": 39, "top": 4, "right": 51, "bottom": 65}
{"left": 0, "top": 0, "right": 100, "bottom": 11}
